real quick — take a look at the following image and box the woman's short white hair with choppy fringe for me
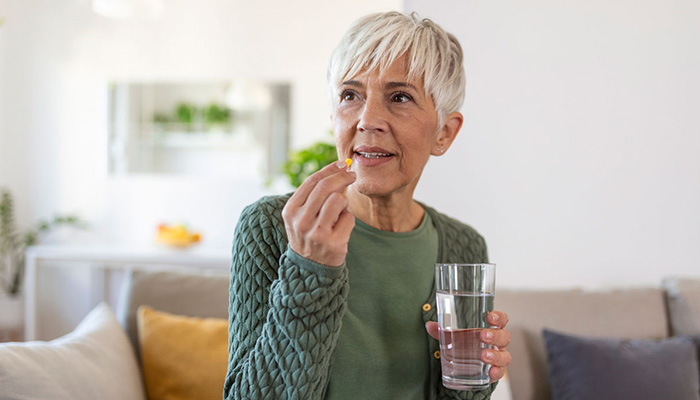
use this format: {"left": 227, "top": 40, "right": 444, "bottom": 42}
{"left": 327, "top": 11, "right": 466, "bottom": 128}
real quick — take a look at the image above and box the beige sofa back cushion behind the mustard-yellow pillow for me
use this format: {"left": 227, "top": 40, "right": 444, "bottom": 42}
{"left": 117, "top": 269, "right": 229, "bottom": 356}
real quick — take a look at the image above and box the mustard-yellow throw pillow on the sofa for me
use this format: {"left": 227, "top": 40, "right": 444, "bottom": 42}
{"left": 137, "top": 306, "right": 228, "bottom": 400}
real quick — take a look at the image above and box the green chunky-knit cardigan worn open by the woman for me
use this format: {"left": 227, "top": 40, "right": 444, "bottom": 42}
{"left": 224, "top": 194, "right": 495, "bottom": 400}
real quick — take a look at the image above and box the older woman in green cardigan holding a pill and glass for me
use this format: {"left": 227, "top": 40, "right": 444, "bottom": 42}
{"left": 224, "top": 12, "right": 511, "bottom": 400}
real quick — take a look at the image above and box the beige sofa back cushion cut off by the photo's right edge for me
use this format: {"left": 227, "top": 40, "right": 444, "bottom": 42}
{"left": 663, "top": 279, "right": 700, "bottom": 335}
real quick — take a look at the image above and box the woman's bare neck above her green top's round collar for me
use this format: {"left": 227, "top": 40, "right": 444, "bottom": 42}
{"left": 346, "top": 186, "right": 425, "bottom": 232}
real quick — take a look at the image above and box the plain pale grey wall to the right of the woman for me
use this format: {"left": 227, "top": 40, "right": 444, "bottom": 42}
{"left": 405, "top": 0, "right": 700, "bottom": 287}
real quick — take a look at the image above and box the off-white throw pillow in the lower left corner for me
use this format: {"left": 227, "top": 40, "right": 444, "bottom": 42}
{"left": 0, "top": 303, "right": 145, "bottom": 400}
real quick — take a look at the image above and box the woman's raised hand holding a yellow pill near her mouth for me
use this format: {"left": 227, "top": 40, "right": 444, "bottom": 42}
{"left": 282, "top": 160, "right": 355, "bottom": 267}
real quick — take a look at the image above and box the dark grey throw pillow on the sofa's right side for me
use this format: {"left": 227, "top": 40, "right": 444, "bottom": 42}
{"left": 543, "top": 329, "right": 700, "bottom": 400}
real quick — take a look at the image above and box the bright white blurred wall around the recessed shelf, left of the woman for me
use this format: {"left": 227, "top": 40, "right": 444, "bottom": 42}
{"left": 0, "top": 0, "right": 400, "bottom": 251}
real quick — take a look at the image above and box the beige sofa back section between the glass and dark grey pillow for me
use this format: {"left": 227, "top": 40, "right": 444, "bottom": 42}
{"left": 495, "top": 288, "right": 668, "bottom": 400}
